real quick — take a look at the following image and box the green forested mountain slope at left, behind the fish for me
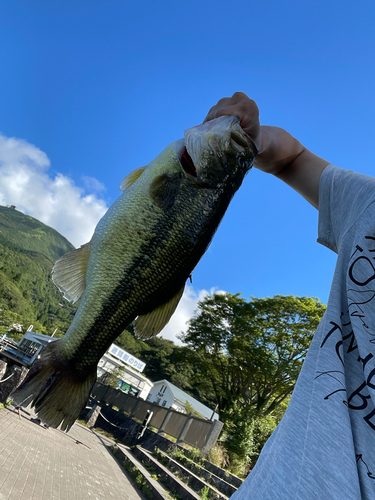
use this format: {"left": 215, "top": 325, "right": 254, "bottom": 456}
{"left": 0, "top": 206, "right": 77, "bottom": 336}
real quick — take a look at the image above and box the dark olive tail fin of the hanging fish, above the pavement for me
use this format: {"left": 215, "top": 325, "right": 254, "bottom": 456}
{"left": 11, "top": 340, "right": 96, "bottom": 432}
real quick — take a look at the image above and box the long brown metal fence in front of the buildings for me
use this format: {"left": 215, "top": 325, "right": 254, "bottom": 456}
{"left": 91, "top": 382, "right": 223, "bottom": 451}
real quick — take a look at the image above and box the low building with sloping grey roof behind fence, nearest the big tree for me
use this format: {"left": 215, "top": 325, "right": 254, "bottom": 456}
{"left": 147, "top": 380, "right": 219, "bottom": 420}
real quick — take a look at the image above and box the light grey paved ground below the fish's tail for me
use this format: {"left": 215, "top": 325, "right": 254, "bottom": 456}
{"left": 0, "top": 407, "right": 145, "bottom": 500}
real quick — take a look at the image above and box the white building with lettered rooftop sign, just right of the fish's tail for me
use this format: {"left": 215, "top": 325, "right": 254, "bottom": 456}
{"left": 97, "top": 344, "right": 154, "bottom": 399}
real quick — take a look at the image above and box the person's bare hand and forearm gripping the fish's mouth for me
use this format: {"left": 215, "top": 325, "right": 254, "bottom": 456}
{"left": 205, "top": 92, "right": 329, "bottom": 208}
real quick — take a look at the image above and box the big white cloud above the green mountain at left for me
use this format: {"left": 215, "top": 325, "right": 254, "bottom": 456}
{"left": 0, "top": 134, "right": 108, "bottom": 246}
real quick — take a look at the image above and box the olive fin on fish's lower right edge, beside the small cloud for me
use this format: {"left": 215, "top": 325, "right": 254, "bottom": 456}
{"left": 134, "top": 285, "right": 185, "bottom": 339}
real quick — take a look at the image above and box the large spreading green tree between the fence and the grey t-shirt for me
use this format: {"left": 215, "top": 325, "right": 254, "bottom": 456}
{"left": 179, "top": 293, "right": 325, "bottom": 472}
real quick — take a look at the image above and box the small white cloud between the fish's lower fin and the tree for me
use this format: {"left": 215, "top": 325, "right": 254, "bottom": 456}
{"left": 160, "top": 285, "right": 225, "bottom": 345}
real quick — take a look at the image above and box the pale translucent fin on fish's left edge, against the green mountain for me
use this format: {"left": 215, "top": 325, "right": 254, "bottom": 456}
{"left": 52, "top": 242, "right": 90, "bottom": 303}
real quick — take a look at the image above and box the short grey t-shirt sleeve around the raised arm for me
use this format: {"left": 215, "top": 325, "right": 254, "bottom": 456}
{"left": 318, "top": 165, "right": 375, "bottom": 253}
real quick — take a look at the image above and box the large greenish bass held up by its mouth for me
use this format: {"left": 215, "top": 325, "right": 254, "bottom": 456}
{"left": 12, "top": 116, "right": 258, "bottom": 432}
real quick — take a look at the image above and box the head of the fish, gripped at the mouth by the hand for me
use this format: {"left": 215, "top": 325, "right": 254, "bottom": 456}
{"left": 179, "top": 116, "right": 258, "bottom": 189}
